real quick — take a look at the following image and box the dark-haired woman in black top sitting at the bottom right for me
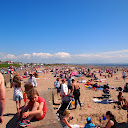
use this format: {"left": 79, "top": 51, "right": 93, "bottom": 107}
{"left": 105, "top": 111, "right": 116, "bottom": 128}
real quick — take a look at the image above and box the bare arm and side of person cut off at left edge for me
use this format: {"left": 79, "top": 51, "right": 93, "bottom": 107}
{"left": 0, "top": 73, "right": 5, "bottom": 124}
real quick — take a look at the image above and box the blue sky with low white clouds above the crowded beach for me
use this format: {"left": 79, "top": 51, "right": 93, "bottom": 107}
{"left": 0, "top": 0, "right": 128, "bottom": 64}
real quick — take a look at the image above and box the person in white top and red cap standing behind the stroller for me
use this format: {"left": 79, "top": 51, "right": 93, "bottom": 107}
{"left": 60, "top": 79, "right": 68, "bottom": 98}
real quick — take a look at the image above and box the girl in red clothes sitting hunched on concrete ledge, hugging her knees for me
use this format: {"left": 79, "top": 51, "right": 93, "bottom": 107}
{"left": 19, "top": 88, "right": 47, "bottom": 127}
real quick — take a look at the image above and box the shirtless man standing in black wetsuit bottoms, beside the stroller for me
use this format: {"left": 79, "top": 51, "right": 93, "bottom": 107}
{"left": 72, "top": 79, "right": 81, "bottom": 109}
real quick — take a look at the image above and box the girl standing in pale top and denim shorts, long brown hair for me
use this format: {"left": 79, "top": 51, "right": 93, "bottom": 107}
{"left": 11, "top": 75, "right": 23, "bottom": 117}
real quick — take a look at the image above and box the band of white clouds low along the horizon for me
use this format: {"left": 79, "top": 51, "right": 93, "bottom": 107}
{"left": 0, "top": 49, "right": 128, "bottom": 64}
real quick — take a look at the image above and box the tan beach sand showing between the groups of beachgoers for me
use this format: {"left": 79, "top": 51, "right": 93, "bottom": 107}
{"left": 0, "top": 69, "right": 128, "bottom": 128}
